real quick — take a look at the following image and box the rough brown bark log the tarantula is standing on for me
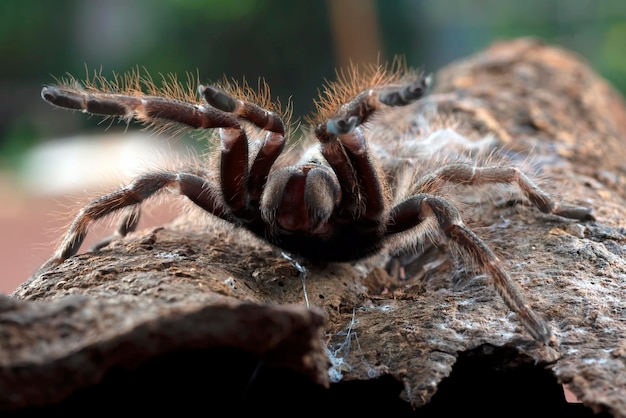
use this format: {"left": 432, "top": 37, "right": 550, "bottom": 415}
{"left": 0, "top": 40, "right": 626, "bottom": 417}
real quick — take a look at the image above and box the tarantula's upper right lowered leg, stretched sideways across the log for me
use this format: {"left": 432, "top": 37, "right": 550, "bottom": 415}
{"left": 418, "top": 164, "right": 594, "bottom": 221}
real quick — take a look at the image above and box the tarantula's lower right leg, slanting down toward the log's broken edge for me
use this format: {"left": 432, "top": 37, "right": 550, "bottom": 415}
{"left": 385, "top": 194, "right": 555, "bottom": 344}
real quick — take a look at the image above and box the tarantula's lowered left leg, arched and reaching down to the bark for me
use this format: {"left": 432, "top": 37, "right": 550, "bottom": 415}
{"left": 36, "top": 171, "right": 224, "bottom": 275}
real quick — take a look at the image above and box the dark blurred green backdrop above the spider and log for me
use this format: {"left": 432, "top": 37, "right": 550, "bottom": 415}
{"left": 0, "top": 0, "right": 626, "bottom": 176}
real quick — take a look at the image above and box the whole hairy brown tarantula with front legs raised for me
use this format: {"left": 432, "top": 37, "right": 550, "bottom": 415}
{"left": 38, "top": 64, "right": 592, "bottom": 343}
